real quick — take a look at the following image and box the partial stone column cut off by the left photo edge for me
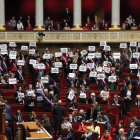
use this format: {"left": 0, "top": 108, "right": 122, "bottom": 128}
{"left": 0, "top": 0, "right": 5, "bottom": 30}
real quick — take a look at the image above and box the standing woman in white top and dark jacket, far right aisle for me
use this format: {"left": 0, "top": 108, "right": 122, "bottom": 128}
{"left": 123, "top": 84, "right": 134, "bottom": 115}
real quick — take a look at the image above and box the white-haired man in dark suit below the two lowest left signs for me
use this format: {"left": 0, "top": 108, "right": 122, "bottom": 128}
{"left": 24, "top": 94, "right": 37, "bottom": 112}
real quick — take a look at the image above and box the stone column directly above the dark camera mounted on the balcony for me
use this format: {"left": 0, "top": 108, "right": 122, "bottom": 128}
{"left": 34, "top": 0, "right": 45, "bottom": 30}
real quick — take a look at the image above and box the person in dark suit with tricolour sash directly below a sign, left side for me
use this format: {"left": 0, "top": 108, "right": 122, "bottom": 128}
{"left": 15, "top": 66, "right": 25, "bottom": 83}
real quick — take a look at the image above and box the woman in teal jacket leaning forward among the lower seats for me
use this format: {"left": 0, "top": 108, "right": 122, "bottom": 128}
{"left": 97, "top": 111, "right": 112, "bottom": 130}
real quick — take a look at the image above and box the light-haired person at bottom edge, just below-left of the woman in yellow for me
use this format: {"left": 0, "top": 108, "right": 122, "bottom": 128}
{"left": 81, "top": 126, "right": 93, "bottom": 140}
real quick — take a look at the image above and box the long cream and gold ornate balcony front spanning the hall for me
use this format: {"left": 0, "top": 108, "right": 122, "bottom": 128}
{"left": 0, "top": 30, "right": 140, "bottom": 43}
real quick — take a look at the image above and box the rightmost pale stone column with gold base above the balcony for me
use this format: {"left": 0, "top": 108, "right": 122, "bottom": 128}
{"left": 110, "top": 0, "right": 120, "bottom": 29}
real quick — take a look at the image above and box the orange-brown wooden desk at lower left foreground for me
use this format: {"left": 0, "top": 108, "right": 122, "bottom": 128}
{"left": 17, "top": 122, "right": 52, "bottom": 140}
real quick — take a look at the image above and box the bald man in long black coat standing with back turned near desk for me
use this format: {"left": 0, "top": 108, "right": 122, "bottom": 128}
{"left": 52, "top": 100, "right": 65, "bottom": 136}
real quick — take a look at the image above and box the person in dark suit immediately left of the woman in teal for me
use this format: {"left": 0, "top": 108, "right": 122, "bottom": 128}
{"left": 86, "top": 104, "right": 97, "bottom": 122}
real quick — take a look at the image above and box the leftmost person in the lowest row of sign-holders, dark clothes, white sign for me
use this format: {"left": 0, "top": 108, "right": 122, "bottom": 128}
{"left": 14, "top": 87, "right": 24, "bottom": 104}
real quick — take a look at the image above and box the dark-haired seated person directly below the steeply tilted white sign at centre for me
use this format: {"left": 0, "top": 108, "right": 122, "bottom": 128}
{"left": 68, "top": 98, "right": 79, "bottom": 111}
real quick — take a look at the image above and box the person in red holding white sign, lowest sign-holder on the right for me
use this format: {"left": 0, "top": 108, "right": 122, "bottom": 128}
{"left": 100, "top": 86, "right": 110, "bottom": 104}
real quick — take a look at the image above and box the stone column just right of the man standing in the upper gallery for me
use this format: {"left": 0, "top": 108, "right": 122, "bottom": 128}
{"left": 72, "top": 0, "right": 83, "bottom": 30}
